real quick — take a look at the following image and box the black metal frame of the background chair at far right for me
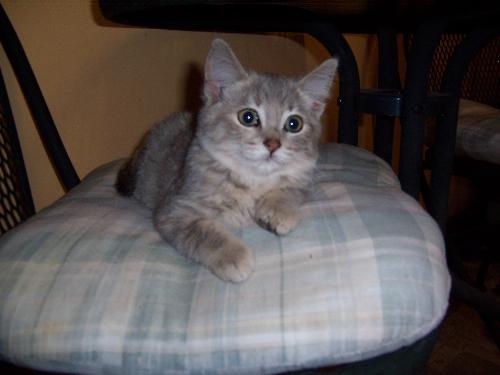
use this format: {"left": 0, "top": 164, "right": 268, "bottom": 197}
{"left": 418, "top": 31, "right": 500, "bottom": 346}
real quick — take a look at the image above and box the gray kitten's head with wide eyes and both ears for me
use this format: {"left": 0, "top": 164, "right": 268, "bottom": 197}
{"left": 198, "top": 39, "right": 338, "bottom": 177}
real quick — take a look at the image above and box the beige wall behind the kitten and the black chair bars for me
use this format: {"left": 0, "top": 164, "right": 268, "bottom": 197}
{"left": 0, "top": 0, "right": 375, "bottom": 212}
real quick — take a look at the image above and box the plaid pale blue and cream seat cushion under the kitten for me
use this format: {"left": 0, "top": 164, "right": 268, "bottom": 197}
{"left": 0, "top": 144, "right": 450, "bottom": 374}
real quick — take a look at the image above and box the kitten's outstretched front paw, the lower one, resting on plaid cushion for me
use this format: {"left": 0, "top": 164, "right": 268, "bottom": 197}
{"left": 209, "top": 244, "right": 255, "bottom": 283}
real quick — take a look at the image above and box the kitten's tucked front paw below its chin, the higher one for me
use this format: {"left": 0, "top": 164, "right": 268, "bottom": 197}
{"left": 255, "top": 205, "right": 300, "bottom": 235}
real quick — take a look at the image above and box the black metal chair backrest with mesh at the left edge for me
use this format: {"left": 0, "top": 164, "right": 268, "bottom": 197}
{"left": 0, "top": 4, "right": 80, "bottom": 235}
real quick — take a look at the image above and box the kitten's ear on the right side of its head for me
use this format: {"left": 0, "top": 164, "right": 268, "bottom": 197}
{"left": 299, "top": 58, "right": 339, "bottom": 111}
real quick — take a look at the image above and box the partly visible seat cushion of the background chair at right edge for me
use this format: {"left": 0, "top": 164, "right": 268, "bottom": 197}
{"left": 456, "top": 99, "right": 500, "bottom": 165}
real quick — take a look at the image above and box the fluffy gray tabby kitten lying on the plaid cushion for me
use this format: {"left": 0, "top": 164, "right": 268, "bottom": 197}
{"left": 116, "top": 39, "right": 338, "bottom": 282}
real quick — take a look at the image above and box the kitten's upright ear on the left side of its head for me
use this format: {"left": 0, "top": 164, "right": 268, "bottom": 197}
{"left": 204, "top": 39, "right": 248, "bottom": 100}
